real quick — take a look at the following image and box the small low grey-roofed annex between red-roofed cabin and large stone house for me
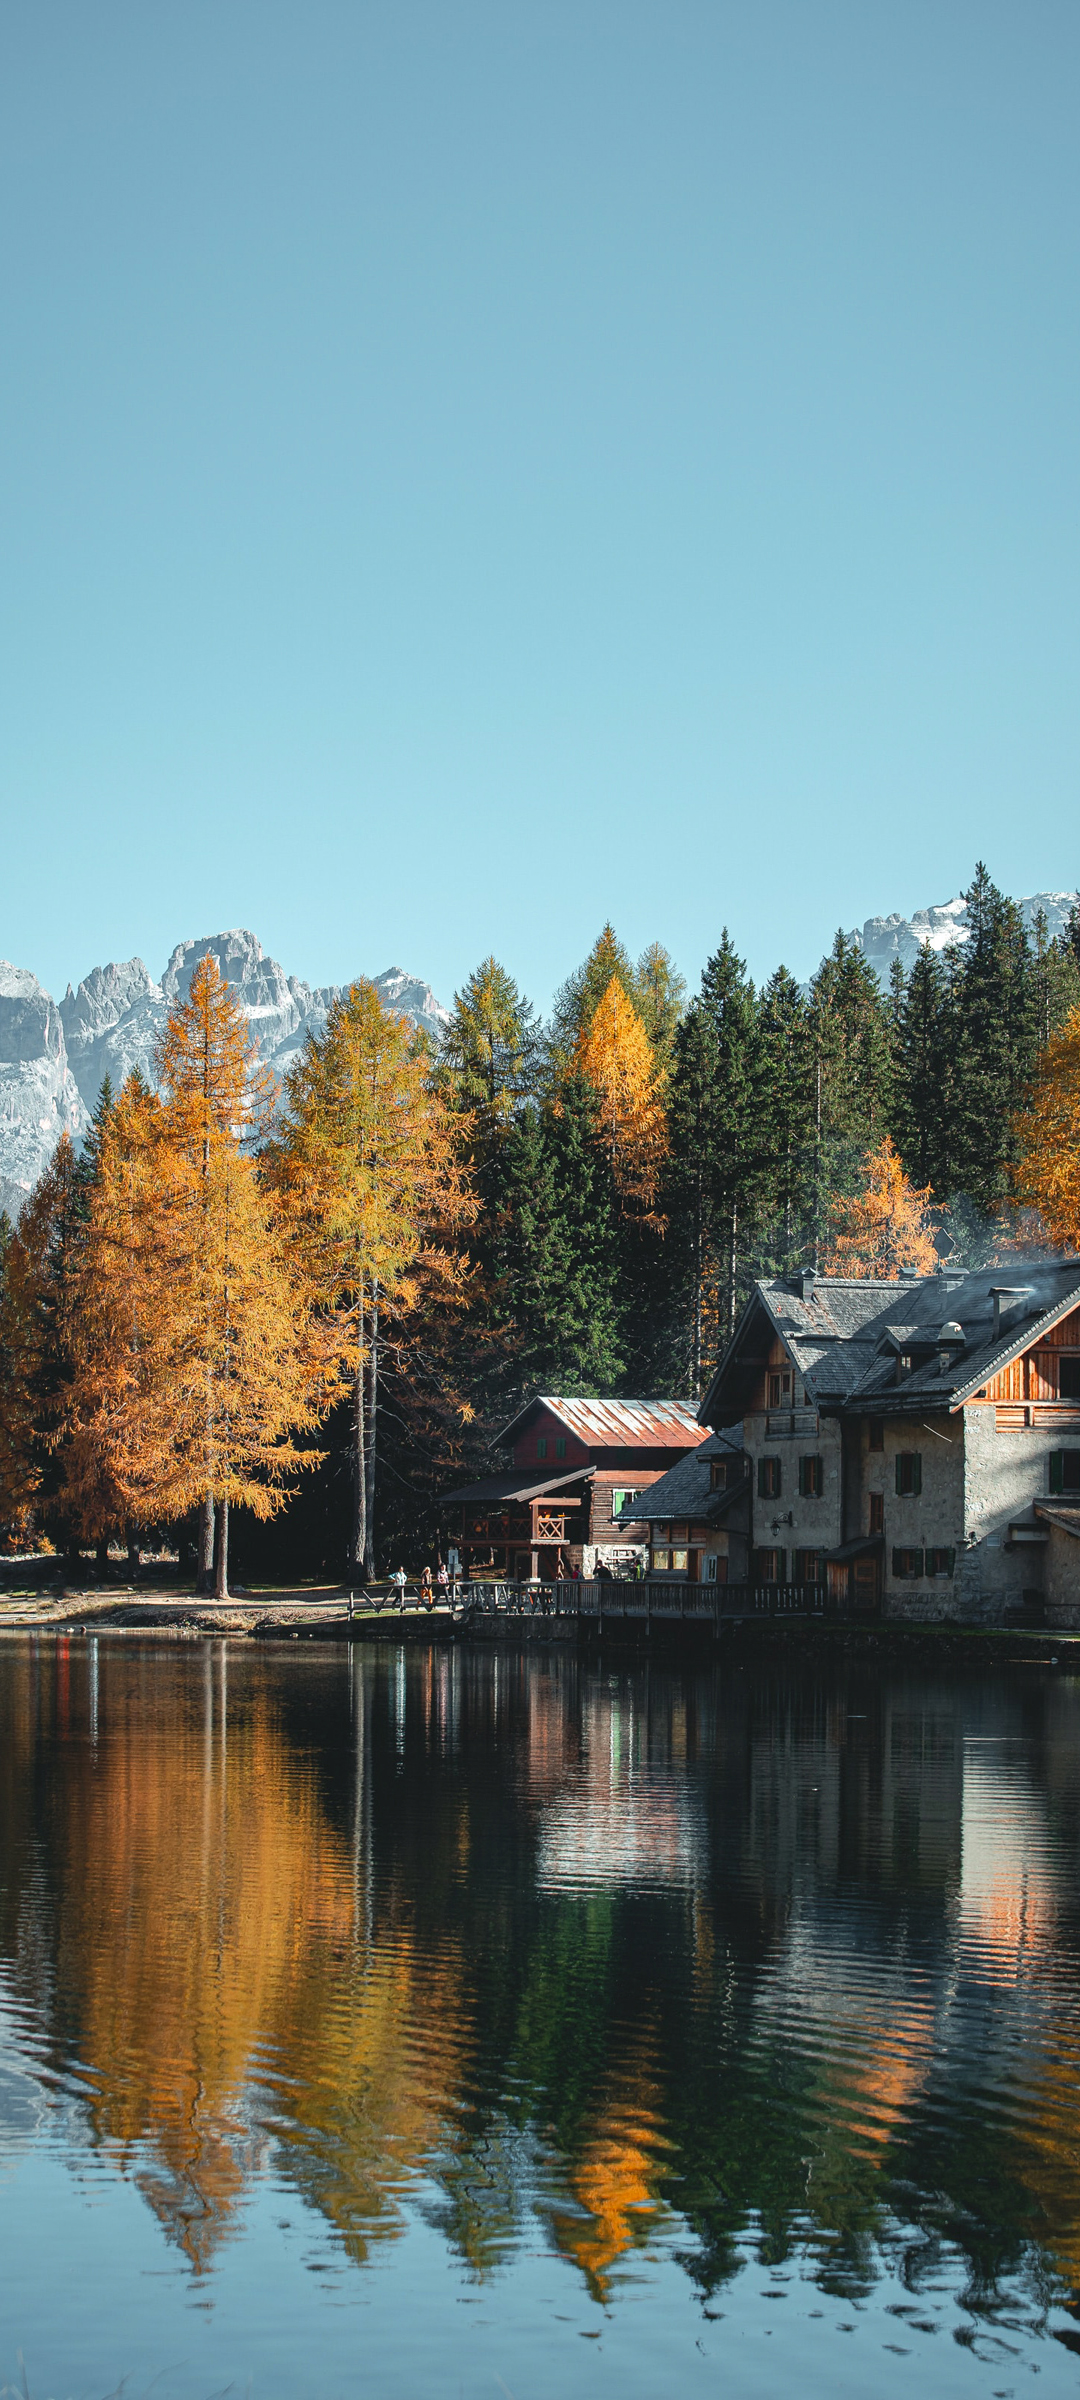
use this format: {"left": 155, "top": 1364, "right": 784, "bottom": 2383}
{"left": 614, "top": 1428, "right": 751, "bottom": 1584}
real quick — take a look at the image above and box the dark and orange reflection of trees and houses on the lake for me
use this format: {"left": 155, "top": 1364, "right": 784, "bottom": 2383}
{"left": 0, "top": 1644, "right": 1080, "bottom": 2302}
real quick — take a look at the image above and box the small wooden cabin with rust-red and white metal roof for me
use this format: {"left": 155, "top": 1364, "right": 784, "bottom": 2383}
{"left": 439, "top": 1394, "right": 701, "bottom": 1582}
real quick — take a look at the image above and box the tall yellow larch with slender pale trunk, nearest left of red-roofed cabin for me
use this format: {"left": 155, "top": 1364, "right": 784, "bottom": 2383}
{"left": 276, "top": 979, "right": 475, "bottom": 1577}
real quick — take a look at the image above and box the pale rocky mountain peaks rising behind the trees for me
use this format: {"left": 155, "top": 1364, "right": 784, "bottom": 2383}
{"left": 0, "top": 893, "right": 1078, "bottom": 1217}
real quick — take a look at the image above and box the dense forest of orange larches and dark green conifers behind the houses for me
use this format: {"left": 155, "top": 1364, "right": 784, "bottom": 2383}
{"left": 0, "top": 866, "right": 1080, "bottom": 1591}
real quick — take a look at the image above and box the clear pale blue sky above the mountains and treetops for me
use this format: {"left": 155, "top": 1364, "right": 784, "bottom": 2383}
{"left": 0, "top": 0, "right": 1080, "bottom": 1003}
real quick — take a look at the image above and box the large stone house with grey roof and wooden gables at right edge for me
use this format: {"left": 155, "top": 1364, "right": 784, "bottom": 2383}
{"left": 701, "top": 1255, "right": 1080, "bottom": 1627}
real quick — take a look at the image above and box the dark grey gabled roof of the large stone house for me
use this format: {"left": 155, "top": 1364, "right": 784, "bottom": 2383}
{"left": 701, "top": 1253, "right": 1080, "bottom": 1423}
